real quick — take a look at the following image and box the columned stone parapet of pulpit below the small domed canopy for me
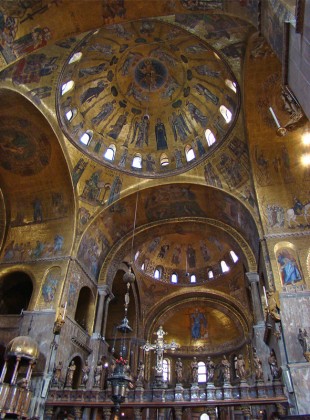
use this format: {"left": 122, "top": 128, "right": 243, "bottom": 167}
{"left": 0, "top": 383, "right": 32, "bottom": 418}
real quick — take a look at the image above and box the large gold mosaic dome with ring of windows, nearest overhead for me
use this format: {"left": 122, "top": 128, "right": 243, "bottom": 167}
{"left": 58, "top": 21, "right": 239, "bottom": 178}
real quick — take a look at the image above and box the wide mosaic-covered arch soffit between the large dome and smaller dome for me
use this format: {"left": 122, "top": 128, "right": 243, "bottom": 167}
{"left": 77, "top": 182, "right": 260, "bottom": 284}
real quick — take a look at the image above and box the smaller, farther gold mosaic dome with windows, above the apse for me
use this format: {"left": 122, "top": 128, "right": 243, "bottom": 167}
{"left": 134, "top": 221, "right": 242, "bottom": 286}
